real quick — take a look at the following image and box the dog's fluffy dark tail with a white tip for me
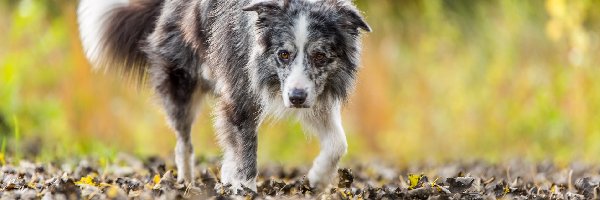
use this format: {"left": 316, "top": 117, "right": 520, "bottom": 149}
{"left": 77, "top": 0, "right": 163, "bottom": 81}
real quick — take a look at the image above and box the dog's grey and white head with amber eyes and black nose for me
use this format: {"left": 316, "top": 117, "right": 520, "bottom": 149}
{"left": 244, "top": 0, "right": 371, "bottom": 108}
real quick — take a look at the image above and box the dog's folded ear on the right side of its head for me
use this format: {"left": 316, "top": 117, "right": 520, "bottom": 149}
{"left": 328, "top": 0, "right": 372, "bottom": 34}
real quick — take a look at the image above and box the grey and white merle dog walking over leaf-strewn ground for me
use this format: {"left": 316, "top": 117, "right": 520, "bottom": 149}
{"left": 78, "top": 0, "right": 371, "bottom": 191}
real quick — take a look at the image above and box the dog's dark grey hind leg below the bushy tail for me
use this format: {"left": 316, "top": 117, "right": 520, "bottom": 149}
{"left": 146, "top": 32, "right": 205, "bottom": 183}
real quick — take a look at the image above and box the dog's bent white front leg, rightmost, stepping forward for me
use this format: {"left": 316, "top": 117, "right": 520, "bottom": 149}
{"left": 302, "top": 103, "right": 348, "bottom": 187}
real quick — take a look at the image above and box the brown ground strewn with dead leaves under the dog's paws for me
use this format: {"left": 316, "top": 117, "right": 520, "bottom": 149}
{"left": 0, "top": 155, "right": 600, "bottom": 199}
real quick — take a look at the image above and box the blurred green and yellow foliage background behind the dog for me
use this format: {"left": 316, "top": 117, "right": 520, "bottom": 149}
{"left": 0, "top": 0, "right": 600, "bottom": 165}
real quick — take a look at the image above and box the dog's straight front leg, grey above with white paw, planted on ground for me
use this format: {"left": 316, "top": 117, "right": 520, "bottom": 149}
{"left": 215, "top": 97, "right": 258, "bottom": 192}
